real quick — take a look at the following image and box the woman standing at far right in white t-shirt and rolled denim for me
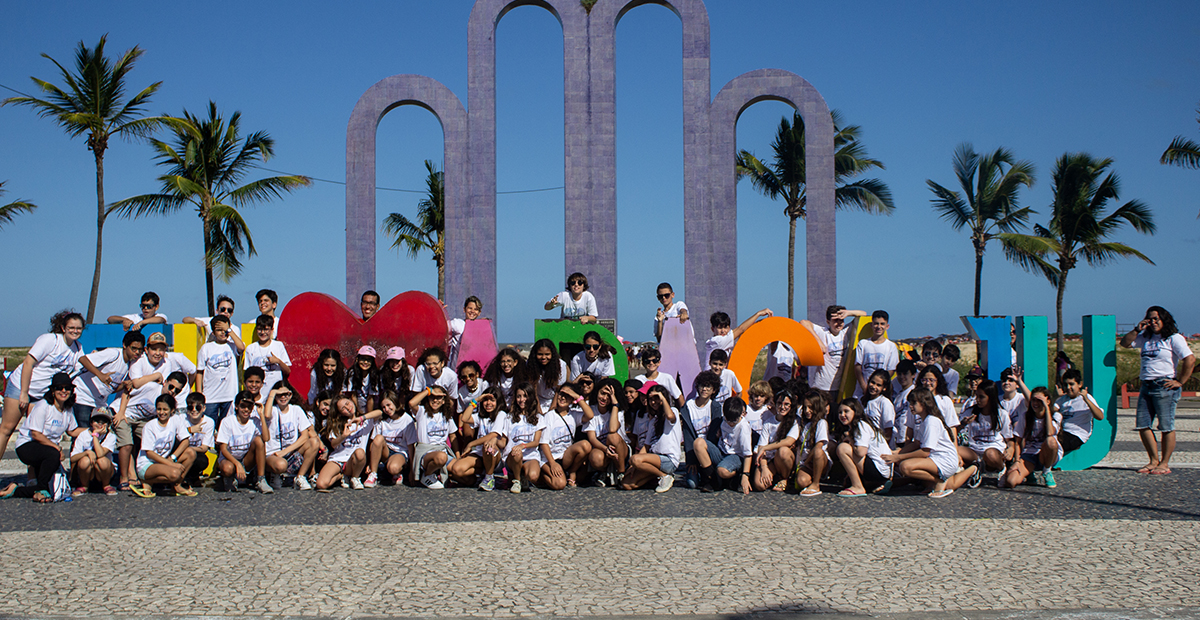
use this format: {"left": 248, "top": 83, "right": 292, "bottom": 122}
{"left": 1121, "top": 306, "right": 1196, "bottom": 475}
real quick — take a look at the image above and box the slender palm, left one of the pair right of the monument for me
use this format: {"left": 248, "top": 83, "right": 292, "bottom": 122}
{"left": 925, "top": 143, "right": 1034, "bottom": 317}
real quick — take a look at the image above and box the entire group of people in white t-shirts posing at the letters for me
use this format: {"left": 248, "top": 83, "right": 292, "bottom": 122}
{"left": 0, "top": 280, "right": 1194, "bottom": 501}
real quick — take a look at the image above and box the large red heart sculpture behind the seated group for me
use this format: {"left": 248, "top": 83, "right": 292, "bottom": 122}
{"left": 276, "top": 290, "right": 450, "bottom": 395}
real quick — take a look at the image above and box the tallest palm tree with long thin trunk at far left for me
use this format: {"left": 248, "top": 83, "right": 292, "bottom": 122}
{"left": 4, "top": 35, "right": 167, "bottom": 323}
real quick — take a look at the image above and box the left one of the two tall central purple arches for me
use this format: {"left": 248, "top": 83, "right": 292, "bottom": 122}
{"left": 460, "top": 0, "right": 588, "bottom": 317}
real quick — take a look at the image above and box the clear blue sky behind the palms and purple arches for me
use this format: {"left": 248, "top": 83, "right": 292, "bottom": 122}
{"left": 0, "top": 0, "right": 1200, "bottom": 345}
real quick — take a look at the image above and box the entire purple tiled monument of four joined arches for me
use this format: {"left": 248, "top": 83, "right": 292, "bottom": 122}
{"left": 346, "top": 0, "right": 838, "bottom": 339}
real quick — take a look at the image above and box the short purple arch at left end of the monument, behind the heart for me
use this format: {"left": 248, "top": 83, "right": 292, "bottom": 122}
{"left": 346, "top": 74, "right": 468, "bottom": 308}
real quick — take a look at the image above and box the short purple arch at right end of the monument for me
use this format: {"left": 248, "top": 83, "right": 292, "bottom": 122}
{"left": 710, "top": 68, "right": 838, "bottom": 326}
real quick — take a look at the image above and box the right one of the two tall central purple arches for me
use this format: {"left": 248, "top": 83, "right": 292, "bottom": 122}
{"left": 590, "top": 0, "right": 712, "bottom": 338}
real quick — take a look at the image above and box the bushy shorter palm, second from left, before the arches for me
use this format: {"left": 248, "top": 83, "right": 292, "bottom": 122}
{"left": 109, "top": 101, "right": 312, "bottom": 313}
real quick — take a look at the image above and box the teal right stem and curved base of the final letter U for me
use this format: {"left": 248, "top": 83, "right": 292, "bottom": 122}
{"left": 1058, "top": 314, "right": 1117, "bottom": 471}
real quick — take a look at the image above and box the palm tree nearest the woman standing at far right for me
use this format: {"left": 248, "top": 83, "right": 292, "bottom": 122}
{"left": 997, "top": 152, "right": 1154, "bottom": 351}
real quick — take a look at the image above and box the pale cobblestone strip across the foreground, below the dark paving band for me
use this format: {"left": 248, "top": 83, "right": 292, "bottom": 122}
{"left": 0, "top": 517, "right": 1200, "bottom": 618}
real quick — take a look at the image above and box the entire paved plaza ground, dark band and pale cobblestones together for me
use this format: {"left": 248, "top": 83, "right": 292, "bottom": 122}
{"left": 0, "top": 409, "right": 1200, "bottom": 619}
